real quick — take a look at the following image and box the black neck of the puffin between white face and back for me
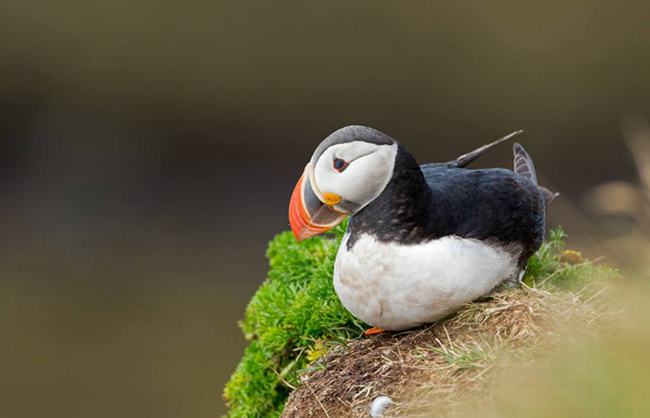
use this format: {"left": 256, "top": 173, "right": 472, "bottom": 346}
{"left": 348, "top": 145, "right": 431, "bottom": 246}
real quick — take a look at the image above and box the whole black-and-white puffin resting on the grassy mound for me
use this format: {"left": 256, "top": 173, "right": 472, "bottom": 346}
{"left": 289, "top": 126, "right": 557, "bottom": 335}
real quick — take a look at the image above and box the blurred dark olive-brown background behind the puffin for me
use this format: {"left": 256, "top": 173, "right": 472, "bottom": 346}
{"left": 0, "top": 0, "right": 650, "bottom": 418}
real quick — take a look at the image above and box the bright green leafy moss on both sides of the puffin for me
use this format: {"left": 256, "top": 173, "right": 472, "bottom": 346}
{"left": 224, "top": 224, "right": 612, "bottom": 418}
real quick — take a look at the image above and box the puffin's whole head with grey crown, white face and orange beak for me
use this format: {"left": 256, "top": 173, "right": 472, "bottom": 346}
{"left": 289, "top": 126, "right": 398, "bottom": 241}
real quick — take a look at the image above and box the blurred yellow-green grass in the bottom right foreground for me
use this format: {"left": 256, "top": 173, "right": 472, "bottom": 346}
{"left": 448, "top": 290, "right": 650, "bottom": 418}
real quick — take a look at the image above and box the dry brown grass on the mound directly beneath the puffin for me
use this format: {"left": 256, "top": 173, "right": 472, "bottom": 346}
{"left": 282, "top": 288, "right": 608, "bottom": 417}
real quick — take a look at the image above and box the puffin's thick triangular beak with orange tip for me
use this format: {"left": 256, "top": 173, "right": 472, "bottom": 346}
{"left": 289, "top": 164, "right": 346, "bottom": 241}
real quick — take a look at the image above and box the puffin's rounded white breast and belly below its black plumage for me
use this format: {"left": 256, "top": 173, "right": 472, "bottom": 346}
{"left": 334, "top": 235, "right": 519, "bottom": 330}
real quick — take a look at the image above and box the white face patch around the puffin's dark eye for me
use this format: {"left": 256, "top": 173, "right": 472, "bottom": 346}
{"left": 311, "top": 141, "right": 397, "bottom": 214}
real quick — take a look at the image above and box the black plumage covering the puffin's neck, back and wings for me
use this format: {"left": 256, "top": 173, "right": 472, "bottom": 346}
{"left": 347, "top": 137, "right": 548, "bottom": 267}
